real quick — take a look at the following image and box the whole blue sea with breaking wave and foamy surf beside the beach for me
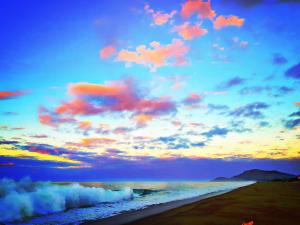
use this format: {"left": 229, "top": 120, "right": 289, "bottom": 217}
{"left": 0, "top": 179, "right": 253, "bottom": 225}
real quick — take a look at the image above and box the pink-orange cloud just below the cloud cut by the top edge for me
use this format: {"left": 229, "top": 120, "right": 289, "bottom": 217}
{"left": 174, "top": 22, "right": 207, "bottom": 40}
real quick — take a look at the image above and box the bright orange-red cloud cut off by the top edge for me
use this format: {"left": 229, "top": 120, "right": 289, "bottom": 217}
{"left": 180, "top": 0, "right": 216, "bottom": 19}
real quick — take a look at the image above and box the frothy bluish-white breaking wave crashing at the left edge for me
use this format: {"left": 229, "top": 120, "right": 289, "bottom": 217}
{"left": 0, "top": 177, "right": 134, "bottom": 222}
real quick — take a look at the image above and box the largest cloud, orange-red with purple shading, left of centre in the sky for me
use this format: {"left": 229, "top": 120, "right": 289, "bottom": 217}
{"left": 39, "top": 78, "right": 177, "bottom": 128}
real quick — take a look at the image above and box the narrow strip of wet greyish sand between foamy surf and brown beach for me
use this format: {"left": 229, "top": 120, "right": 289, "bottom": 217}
{"left": 81, "top": 187, "right": 245, "bottom": 225}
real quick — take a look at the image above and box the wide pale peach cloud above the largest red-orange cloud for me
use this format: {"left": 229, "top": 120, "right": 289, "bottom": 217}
{"left": 117, "top": 39, "right": 189, "bottom": 71}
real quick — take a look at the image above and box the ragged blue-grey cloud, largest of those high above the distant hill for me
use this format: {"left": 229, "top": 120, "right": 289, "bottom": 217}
{"left": 229, "top": 102, "right": 270, "bottom": 119}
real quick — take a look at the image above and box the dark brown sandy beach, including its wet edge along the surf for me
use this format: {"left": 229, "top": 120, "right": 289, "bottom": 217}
{"left": 85, "top": 182, "right": 300, "bottom": 225}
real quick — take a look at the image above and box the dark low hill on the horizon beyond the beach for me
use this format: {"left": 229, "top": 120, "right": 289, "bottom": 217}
{"left": 212, "top": 169, "right": 297, "bottom": 181}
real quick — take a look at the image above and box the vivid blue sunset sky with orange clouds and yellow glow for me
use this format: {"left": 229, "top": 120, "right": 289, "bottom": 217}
{"left": 0, "top": 0, "right": 300, "bottom": 181}
